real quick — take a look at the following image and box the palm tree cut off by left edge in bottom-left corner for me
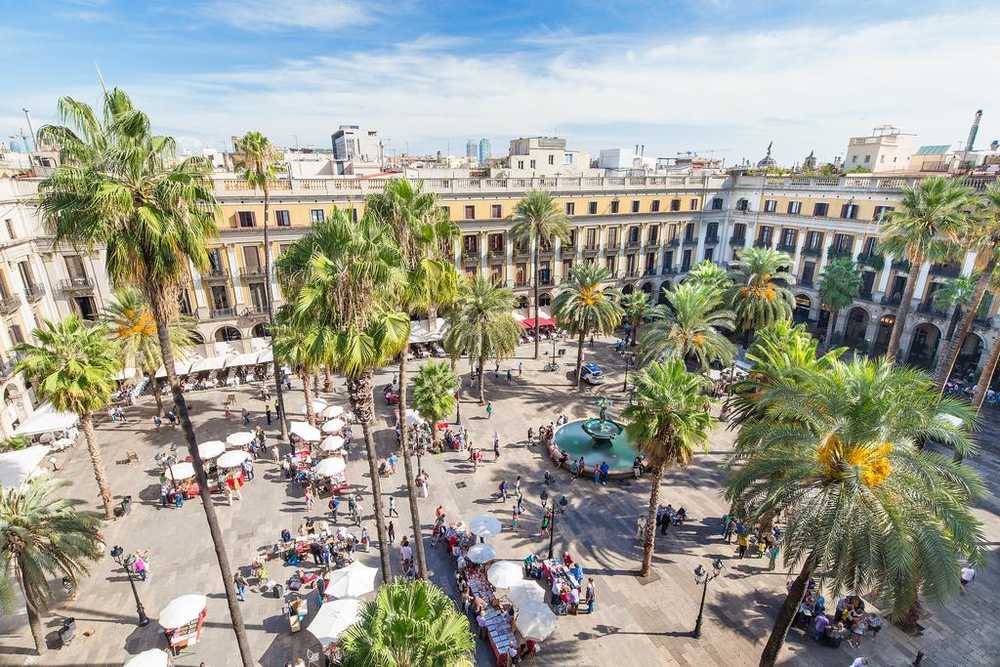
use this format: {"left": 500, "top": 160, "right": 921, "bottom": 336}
{"left": 0, "top": 476, "right": 101, "bottom": 655}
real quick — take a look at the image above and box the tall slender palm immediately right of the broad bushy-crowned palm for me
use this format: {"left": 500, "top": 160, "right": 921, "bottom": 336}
{"left": 365, "top": 179, "right": 458, "bottom": 579}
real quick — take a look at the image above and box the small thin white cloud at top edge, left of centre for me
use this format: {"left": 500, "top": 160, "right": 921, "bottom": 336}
{"left": 204, "top": 0, "right": 372, "bottom": 32}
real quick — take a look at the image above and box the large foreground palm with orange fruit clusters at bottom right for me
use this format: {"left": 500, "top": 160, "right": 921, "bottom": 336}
{"left": 726, "top": 359, "right": 982, "bottom": 665}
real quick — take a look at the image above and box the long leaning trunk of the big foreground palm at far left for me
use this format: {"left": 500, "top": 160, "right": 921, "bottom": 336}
{"left": 146, "top": 296, "right": 255, "bottom": 667}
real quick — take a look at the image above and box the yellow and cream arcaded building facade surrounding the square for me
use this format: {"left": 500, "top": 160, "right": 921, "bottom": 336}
{"left": 0, "top": 174, "right": 998, "bottom": 432}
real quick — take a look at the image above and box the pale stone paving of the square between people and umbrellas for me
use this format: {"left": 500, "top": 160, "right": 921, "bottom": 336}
{"left": 0, "top": 341, "right": 1000, "bottom": 667}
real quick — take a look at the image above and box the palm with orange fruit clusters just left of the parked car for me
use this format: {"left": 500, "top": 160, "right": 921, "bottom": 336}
{"left": 552, "top": 264, "right": 625, "bottom": 388}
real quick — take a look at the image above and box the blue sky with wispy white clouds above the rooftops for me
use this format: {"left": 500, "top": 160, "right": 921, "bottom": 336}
{"left": 0, "top": 0, "right": 1000, "bottom": 163}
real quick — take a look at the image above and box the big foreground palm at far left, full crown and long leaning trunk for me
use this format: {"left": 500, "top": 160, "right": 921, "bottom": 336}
{"left": 38, "top": 88, "right": 254, "bottom": 667}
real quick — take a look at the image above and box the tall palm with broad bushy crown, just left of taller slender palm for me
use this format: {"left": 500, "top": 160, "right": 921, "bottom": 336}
{"left": 275, "top": 209, "right": 410, "bottom": 582}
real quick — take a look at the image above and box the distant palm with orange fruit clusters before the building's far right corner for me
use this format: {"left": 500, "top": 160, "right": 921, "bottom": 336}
{"left": 731, "top": 248, "right": 795, "bottom": 347}
